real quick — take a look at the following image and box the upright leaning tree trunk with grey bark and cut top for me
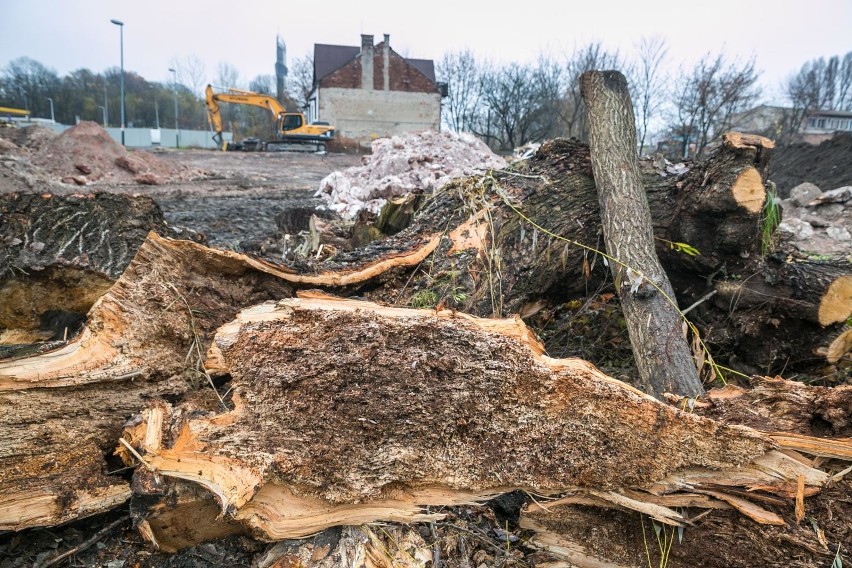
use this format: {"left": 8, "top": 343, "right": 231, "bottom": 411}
{"left": 580, "top": 71, "right": 704, "bottom": 396}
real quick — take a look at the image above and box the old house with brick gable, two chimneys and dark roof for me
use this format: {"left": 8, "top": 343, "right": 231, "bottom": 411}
{"left": 307, "top": 34, "right": 441, "bottom": 146}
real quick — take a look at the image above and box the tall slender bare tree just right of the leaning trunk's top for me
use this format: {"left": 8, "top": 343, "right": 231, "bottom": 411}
{"left": 630, "top": 36, "right": 669, "bottom": 155}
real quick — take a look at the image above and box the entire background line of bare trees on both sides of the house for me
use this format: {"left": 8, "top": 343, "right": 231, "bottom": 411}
{"left": 0, "top": 43, "right": 852, "bottom": 156}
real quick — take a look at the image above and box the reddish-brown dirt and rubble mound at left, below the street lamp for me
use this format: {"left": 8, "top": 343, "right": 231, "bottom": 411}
{"left": 0, "top": 121, "right": 205, "bottom": 190}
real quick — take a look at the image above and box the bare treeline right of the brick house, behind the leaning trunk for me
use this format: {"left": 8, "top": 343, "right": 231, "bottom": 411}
{"left": 437, "top": 38, "right": 852, "bottom": 156}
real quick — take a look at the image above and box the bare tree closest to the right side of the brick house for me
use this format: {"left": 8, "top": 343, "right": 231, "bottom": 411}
{"left": 436, "top": 50, "right": 482, "bottom": 132}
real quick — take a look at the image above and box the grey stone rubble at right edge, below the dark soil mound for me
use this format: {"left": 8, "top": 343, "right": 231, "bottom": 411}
{"left": 778, "top": 182, "right": 852, "bottom": 254}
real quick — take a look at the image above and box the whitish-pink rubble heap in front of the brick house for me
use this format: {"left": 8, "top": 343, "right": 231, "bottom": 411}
{"left": 316, "top": 130, "right": 506, "bottom": 219}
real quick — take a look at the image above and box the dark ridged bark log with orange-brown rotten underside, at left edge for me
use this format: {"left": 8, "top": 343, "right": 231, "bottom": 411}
{"left": 0, "top": 193, "right": 196, "bottom": 345}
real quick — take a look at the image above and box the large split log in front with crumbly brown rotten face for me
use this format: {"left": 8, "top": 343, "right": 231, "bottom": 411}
{"left": 115, "top": 295, "right": 852, "bottom": 550}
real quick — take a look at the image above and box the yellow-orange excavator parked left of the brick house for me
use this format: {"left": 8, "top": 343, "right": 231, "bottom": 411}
{"left": 205, "top": 85, "right": 334, "bottom": 152}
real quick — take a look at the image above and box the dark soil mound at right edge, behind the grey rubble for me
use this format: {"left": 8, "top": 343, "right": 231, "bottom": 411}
{"left": 769, "top": 133, "right": 852, "bottom": 198}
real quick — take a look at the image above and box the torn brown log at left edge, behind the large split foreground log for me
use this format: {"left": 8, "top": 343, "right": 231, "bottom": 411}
{"left": 0, "top": 234, "right": 292, "bottom": 530}
